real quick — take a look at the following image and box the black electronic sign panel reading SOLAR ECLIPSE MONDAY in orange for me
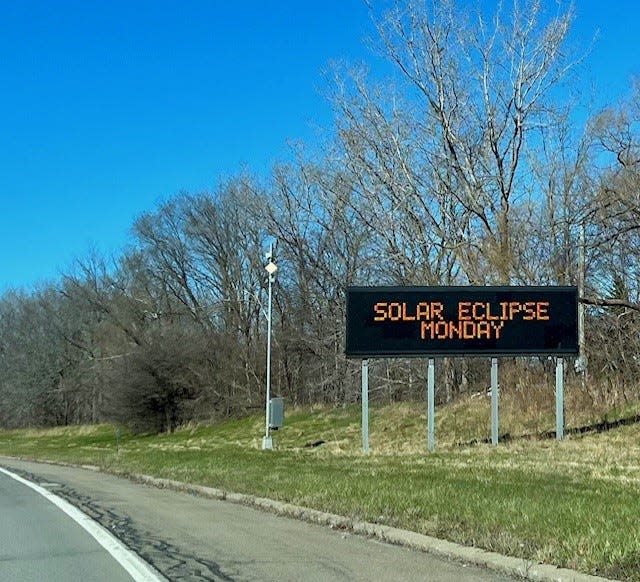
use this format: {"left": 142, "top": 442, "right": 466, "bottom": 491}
{"left": 346, "top": 287, "right": 578, "bottom": 357}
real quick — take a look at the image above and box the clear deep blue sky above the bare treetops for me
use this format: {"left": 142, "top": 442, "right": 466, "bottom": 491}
{"left": 0, "top": 0, "right": 640, "bottom": 292}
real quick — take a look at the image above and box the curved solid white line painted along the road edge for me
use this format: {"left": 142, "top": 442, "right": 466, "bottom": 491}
{"left": 0, "top": 467, "right": 163, "bottom": 582}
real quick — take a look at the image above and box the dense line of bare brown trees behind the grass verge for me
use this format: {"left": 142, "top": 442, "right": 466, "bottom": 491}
{"left": 0, "top": 0, "right": 640, "bottom": 431}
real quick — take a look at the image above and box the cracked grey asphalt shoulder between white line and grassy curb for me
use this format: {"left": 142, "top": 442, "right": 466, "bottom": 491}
{"left": 0, "top": 458, "right": 509, "bottom": 582}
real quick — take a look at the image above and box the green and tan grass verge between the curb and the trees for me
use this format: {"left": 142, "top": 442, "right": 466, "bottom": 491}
{"left": 0, "top": 399, "right": 640, "bottom": 580}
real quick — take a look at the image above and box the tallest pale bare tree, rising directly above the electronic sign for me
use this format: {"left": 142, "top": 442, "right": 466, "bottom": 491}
{"left": 358, "top": 1, "right": 574, "bottom": 283}
